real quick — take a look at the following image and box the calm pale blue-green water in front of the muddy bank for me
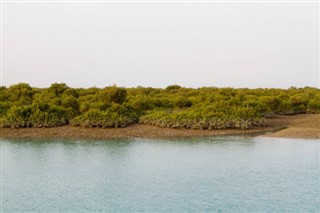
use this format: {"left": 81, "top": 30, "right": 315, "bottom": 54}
{"left": 0, "top": 137, "right": 320, "bottom": 212}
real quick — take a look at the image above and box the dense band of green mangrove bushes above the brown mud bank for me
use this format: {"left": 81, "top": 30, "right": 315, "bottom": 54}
{"left": 0, "top": 83, "right": 320, "bottom": 129}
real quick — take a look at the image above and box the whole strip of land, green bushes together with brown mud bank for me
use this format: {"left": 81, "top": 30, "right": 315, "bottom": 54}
{"left": 0, "top": 83, "right": 320, "bottom": 138}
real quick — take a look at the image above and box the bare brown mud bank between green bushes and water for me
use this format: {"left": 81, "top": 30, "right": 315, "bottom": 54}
{"left": 0, "top": 114, "right": 320, "bottom": 139}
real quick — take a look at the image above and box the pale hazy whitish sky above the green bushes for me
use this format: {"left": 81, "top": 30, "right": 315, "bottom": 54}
{"left": 2, "top": 2, "right": 319, "bottom": 88}
